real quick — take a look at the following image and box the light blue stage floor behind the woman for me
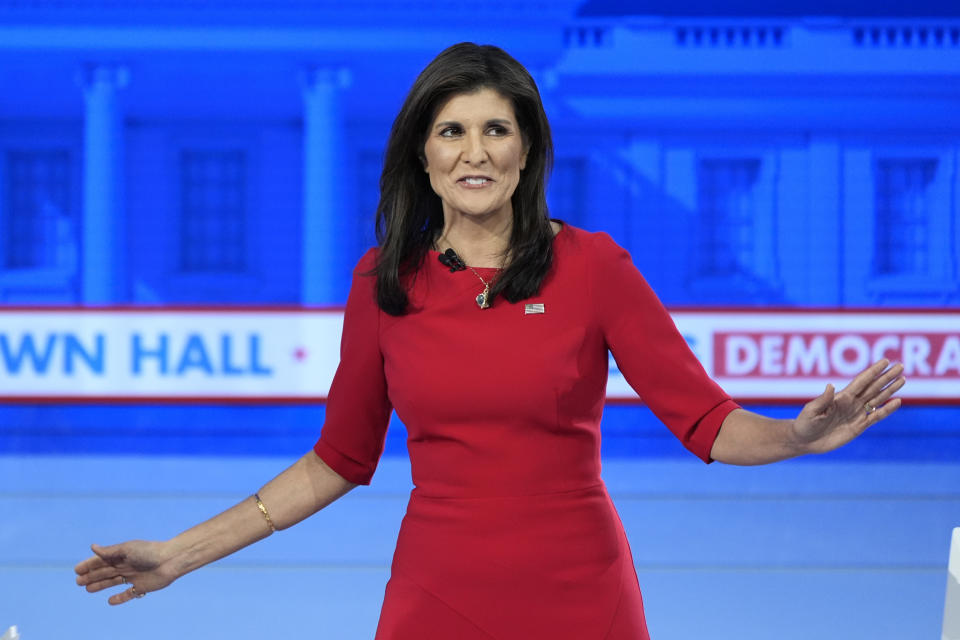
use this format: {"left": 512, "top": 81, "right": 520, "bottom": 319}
{"left": 0, "top": 456, "right": 960, "bottom": 640}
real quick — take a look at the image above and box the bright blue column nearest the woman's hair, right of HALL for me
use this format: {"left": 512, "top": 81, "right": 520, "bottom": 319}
{"left": 300, "top": 67, "right": 357, "bottom": 305}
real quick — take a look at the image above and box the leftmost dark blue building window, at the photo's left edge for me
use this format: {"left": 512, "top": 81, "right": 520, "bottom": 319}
{"left": 2, "top": 150, "right": 76, "bottom": 269}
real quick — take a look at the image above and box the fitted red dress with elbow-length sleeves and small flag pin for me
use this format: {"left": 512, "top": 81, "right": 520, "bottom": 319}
{"left": 315, "top": 225, "right": 737, "bottom": 640}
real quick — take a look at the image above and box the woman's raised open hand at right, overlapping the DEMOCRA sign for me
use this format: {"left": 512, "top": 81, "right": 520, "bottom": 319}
{"left": 792, "top": 360, "right": 906, "bottom": 453}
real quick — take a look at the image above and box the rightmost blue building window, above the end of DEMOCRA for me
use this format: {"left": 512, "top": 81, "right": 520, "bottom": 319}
{"left": 874, "top": 158, "right": 937, "bottom": 275}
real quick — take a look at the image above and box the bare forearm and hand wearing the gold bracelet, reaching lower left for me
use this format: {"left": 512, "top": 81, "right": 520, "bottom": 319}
{"left": 75, "top": 451, "right": 356, "bottom": 604}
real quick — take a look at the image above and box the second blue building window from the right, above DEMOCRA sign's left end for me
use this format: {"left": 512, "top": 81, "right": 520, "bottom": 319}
{"left": 695, "top": 158, "right": 760, "bottom": 276}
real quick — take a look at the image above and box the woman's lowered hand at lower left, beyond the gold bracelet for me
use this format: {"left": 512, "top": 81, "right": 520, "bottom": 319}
{"left": 74, "top": 540, "right": 178, "bottom": 604}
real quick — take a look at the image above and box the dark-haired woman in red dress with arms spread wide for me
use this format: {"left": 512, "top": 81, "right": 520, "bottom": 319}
{"left": 77, "top": 44, "right": 904, "bottom": 640}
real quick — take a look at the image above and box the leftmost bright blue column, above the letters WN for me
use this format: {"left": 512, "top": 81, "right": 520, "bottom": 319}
{"left": 79, "top": 65, "right": 129, "bottom": 304}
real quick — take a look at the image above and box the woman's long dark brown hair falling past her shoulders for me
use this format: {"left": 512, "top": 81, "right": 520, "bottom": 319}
{"left": 375, "top": 42, "right": 553, "bottom": 316}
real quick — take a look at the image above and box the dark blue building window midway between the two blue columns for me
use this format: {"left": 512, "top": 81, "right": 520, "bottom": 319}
{"left": 180, "top": 150, "right": 247, "bottom": 273}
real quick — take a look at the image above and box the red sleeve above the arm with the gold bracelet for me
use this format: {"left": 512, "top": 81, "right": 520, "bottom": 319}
{"left": 313, "top": 249, "right": 391, "bottom": 484}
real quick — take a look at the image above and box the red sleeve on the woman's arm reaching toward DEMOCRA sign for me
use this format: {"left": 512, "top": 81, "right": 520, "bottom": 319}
{"left": 591, "top": 233, "right": 739, "bottom": 462}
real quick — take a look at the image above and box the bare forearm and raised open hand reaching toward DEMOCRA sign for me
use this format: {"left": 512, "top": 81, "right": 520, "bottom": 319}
{"left": 710, "top": 360, "right": 905, "bottom": 465}
